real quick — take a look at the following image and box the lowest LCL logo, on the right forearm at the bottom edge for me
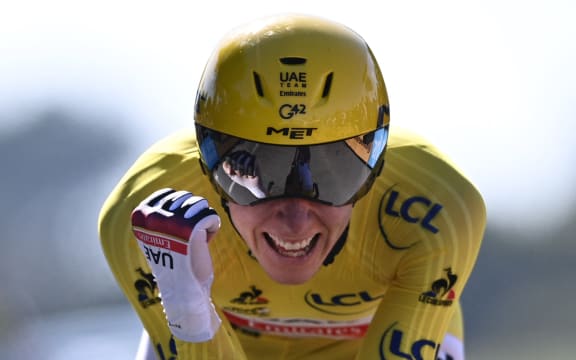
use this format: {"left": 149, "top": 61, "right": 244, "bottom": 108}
{"left": 380, "top": 322, "right": 438, "bottom": 360}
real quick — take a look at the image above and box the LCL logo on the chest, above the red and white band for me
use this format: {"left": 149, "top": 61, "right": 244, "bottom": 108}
{"left": 304, "top": 291, "right": 384, "bottom": 315}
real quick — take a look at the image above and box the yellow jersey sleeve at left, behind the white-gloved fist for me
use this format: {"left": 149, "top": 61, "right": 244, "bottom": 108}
{"left": 98, "top": 133, "right": 244, "bottom": 359}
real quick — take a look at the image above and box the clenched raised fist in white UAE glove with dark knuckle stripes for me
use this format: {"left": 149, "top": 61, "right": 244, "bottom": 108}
{"left": 132, "top": 188, "right": 220, "bottom": 342}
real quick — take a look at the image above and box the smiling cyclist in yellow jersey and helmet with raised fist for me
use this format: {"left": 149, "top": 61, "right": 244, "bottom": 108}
{"left": 99, "top": 14, "right": 486, "bottom": 360}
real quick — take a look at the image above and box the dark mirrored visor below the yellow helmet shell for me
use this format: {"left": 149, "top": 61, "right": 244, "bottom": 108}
{"left": 196, "top": 125, "right": 388, "bottom": 206}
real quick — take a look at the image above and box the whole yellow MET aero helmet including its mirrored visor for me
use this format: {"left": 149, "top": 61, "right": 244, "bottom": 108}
{"left": 195, "top": 15, "right": 390, "bottom": 206}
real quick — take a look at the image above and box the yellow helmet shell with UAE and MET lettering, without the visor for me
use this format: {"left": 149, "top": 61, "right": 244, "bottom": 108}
{"left": 195, "top": 15, "right": 389, "bottom": 145}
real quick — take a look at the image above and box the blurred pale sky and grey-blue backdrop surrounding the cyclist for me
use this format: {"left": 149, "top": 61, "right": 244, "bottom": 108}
{"left": 0, "top": 0, "right": 576, "bottom": 360}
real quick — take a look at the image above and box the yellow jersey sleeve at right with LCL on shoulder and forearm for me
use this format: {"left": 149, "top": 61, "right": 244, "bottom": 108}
{"left": 357, "top": 130, "right": 486, "bottom": 360}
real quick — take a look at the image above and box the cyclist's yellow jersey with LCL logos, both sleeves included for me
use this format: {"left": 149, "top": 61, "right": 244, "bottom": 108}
{"left": 99, "top": 125, "right": 486, "bottom": 360}
